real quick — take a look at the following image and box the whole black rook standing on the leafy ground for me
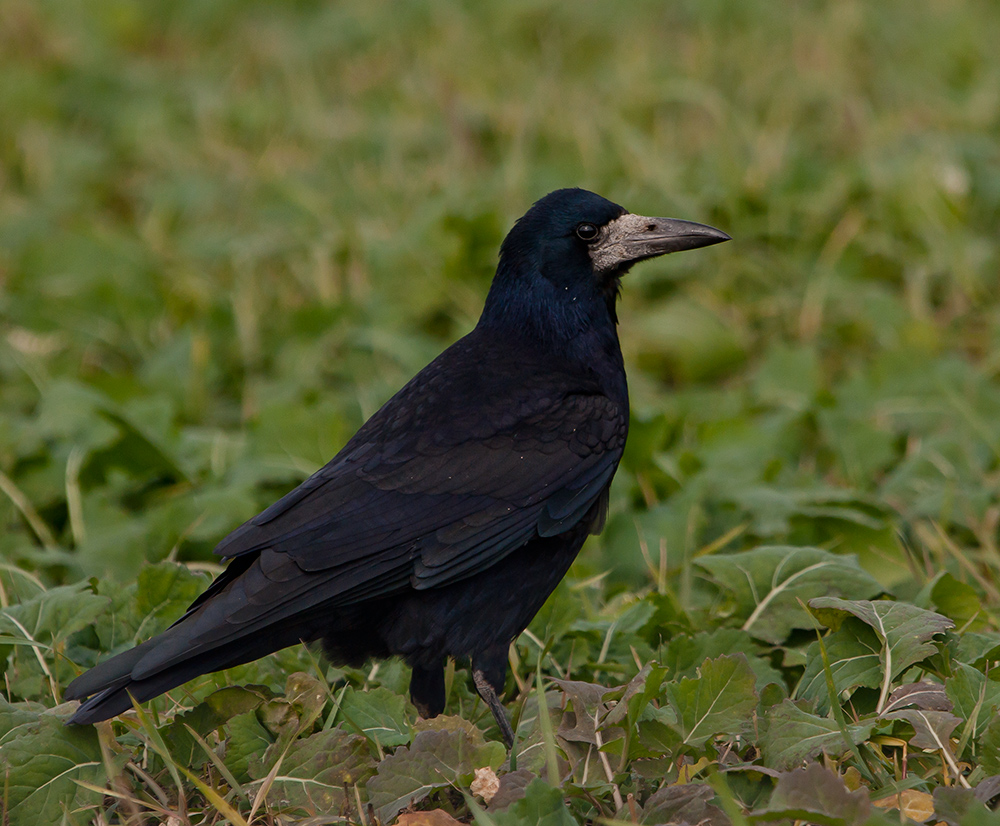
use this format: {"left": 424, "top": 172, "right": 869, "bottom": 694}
{"left": 66, "top": 189, "right": 729, "bottom": 747}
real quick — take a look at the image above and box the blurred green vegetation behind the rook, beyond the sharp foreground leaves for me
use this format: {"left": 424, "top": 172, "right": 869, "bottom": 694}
{"left": 0, "top": 0, "right": 1000, "bottom": 604}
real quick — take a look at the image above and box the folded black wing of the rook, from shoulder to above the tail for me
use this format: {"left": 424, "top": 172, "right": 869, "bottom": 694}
{"left": 217, "top": 380, "right": 627, "bottom": 600}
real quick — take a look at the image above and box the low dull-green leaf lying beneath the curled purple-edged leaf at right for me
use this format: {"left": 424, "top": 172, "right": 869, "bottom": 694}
{"left": 761, "top": 700, "right": 875, "bottom": 769}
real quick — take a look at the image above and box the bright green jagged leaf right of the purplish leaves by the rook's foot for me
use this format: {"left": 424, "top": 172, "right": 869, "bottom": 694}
{"left": 665, "top": 654, "right": 757, "bottom": 748}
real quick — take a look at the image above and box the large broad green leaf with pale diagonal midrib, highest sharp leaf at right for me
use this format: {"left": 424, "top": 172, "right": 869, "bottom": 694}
{"left": 695, "top": 546, "right": 881, "bottom": 643}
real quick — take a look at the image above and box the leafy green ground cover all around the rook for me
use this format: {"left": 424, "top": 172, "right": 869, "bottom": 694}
{"left": 0, "top": 0, "right": 1000, "bottom": 826}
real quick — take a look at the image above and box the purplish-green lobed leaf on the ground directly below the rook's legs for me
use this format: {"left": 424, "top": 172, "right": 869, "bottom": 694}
{"left": 368, "top": 717, "right": 507, "bottom": 822}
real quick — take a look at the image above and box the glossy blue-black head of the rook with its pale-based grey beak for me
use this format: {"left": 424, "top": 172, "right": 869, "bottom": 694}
{"left": 484, "top": 189, "right": 729, "bottom": 334}
